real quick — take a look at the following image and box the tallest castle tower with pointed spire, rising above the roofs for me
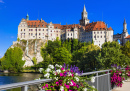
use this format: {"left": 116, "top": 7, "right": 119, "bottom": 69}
{"left": 80, "top": 5, "right": 89, "bottom": 26}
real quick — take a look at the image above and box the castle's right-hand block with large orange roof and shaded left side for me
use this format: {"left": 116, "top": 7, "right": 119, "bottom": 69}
{"left": 80, "top": 21, "right": 113, "bottom": 47}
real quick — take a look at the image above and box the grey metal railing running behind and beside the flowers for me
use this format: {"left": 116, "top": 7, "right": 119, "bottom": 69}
{"left": 0, "top": 70, "right": 118, "bottom": 91}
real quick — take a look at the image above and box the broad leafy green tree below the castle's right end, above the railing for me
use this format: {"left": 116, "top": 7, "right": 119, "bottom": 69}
{"left": 97, "top": 41, "right": 130, "bottom": 68}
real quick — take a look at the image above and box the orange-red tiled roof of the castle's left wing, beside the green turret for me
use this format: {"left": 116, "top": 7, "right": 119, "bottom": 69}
{"left": 27, "top": 20, "right": 47, "bottom": 27}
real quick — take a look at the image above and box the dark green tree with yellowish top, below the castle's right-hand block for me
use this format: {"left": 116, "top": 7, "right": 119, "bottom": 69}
{"left": 78, "top": 44, "right": 100, "bottom": 72}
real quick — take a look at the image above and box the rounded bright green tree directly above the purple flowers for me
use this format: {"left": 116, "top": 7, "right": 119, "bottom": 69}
{"left": 53, "top": 47, "right": 72, "bottom": 64}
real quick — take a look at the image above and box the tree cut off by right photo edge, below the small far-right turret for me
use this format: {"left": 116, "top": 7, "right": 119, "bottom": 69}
{"left": 121, "top": 40, "right": 130, "bottom": 58}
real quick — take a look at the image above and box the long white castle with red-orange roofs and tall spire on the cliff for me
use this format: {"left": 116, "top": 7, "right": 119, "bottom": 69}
{"left": 18, "top": 5, "right": 127, "bottom": 47}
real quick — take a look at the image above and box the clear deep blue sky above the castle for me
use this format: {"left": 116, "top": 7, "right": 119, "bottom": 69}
{"left": 0, "top": 0, "right": 130, "bottom": 58}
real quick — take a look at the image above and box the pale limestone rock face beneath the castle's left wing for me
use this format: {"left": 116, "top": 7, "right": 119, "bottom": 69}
{"left": 11, "top": 39, "right": 46, "bottom": 67}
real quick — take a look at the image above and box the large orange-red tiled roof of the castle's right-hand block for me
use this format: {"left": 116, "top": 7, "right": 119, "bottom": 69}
{"left": 85, "top": 21, "right": 113, "bottom": 31}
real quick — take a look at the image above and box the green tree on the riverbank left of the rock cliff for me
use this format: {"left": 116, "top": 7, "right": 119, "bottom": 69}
{"left": 1, "top": 47, "right": 25, "bottom": 72}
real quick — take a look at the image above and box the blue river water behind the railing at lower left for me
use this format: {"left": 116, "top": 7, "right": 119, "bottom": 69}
{"left": 0, "top": 73, "right": 42, "bottom": 91}
